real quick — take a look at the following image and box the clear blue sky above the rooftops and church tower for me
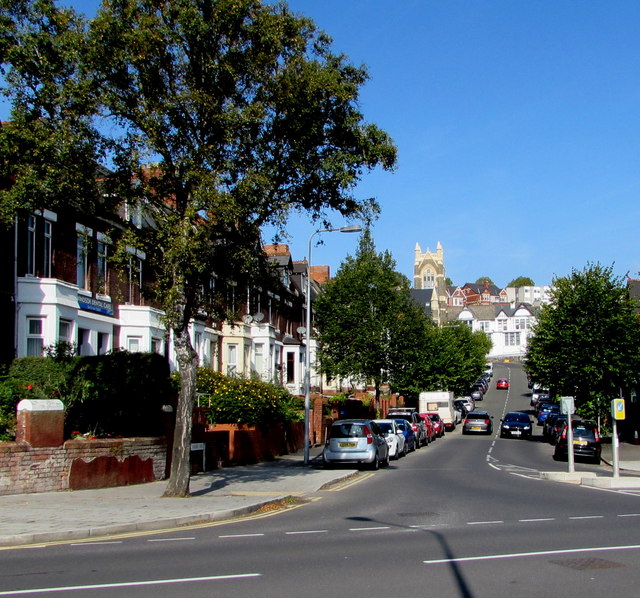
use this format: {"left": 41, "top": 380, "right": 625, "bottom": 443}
{"left": 28, "top": 0, "right": 640, "bottom": 285}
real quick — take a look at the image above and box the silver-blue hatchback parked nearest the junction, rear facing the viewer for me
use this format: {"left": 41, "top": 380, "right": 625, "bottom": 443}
{"left": 322, "top": 419, "right": 389, "bottom": 469}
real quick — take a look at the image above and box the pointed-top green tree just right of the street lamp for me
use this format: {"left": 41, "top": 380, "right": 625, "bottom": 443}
{"left": 314, "top": 230, "right": 428, "bottom": 403}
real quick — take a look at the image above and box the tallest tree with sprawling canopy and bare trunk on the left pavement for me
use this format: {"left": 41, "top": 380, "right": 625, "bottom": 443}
{"left": 0, "top": 0, "right": 396, "bottom": 496}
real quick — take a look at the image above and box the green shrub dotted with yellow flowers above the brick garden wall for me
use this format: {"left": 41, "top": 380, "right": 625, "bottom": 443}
{"left": 196, "top": 368, "right": 299, "bottom": 425}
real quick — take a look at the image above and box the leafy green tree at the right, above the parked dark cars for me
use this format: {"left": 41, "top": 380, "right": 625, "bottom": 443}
{"left": 526, "top": 264, "right": 640, "bottom": 424}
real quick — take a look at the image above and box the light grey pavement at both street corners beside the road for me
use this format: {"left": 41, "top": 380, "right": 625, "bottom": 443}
{"left": 0, "top": 443, "right": 640, "bottom": 548}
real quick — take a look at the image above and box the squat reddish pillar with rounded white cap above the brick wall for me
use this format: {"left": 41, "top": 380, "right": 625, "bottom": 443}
{"left": 16, "top": 399, "right": 64, "bottom": 447}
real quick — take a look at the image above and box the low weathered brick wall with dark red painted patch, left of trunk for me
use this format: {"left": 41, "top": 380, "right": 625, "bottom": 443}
{"left": 0, "top": 438, "right": 167, "bottom": 494}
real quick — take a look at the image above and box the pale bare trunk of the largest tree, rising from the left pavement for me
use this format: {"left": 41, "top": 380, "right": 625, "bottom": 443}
{"left": 163, "top": 326, "right": 198, "bottom": 497}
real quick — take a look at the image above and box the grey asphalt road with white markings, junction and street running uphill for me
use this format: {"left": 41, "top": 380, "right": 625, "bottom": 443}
{"left": 0, "top": 364, "right": 640, "bottom": 598}
